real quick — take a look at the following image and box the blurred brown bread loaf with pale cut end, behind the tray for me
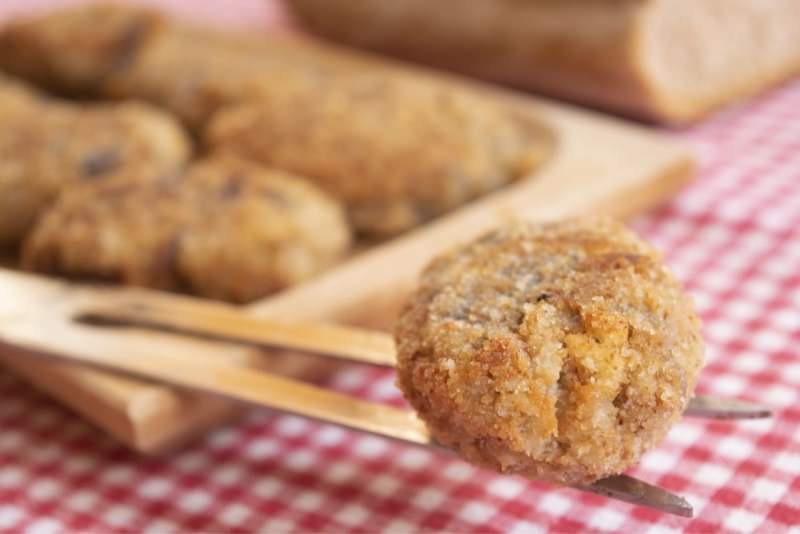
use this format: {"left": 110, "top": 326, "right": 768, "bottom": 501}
{"left": 288, "top": 0, "right": 800, "bottom": 122}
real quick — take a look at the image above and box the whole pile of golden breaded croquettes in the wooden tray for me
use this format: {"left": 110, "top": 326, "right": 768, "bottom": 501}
{"left": 0, "top": 5, "right": 547, "bottom": 302}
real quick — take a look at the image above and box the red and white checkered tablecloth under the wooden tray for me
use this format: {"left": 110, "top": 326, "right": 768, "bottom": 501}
{"left": 0, "top": 0, "right": 800, "bottom": 533}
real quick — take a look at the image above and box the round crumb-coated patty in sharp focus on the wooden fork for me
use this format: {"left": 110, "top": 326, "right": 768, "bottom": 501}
{"left": 396, "top": 219, "right": 703, "bottom": 484}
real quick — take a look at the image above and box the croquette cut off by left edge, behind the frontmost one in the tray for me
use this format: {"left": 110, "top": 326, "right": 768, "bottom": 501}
{"left": 0, "top": 76, "right": 190, "bottom": 246}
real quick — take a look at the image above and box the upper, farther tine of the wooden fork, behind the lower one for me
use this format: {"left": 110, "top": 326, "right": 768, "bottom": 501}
{"left": 76, "top": 290, "right": 772, "bottom": 419}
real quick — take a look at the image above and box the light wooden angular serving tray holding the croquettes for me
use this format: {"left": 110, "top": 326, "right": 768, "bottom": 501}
{"left": 0, "top": 36, "right": 693, "bottom": 453}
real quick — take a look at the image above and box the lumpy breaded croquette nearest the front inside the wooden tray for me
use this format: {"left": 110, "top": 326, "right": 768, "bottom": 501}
{"left": 23, "top": 158, "right": 350, "bottom": 302}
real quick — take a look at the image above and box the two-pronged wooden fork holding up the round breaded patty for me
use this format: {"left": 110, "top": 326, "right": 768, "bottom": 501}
{"left": 0, "top": 269, "right": 771, "bottom": 517}
